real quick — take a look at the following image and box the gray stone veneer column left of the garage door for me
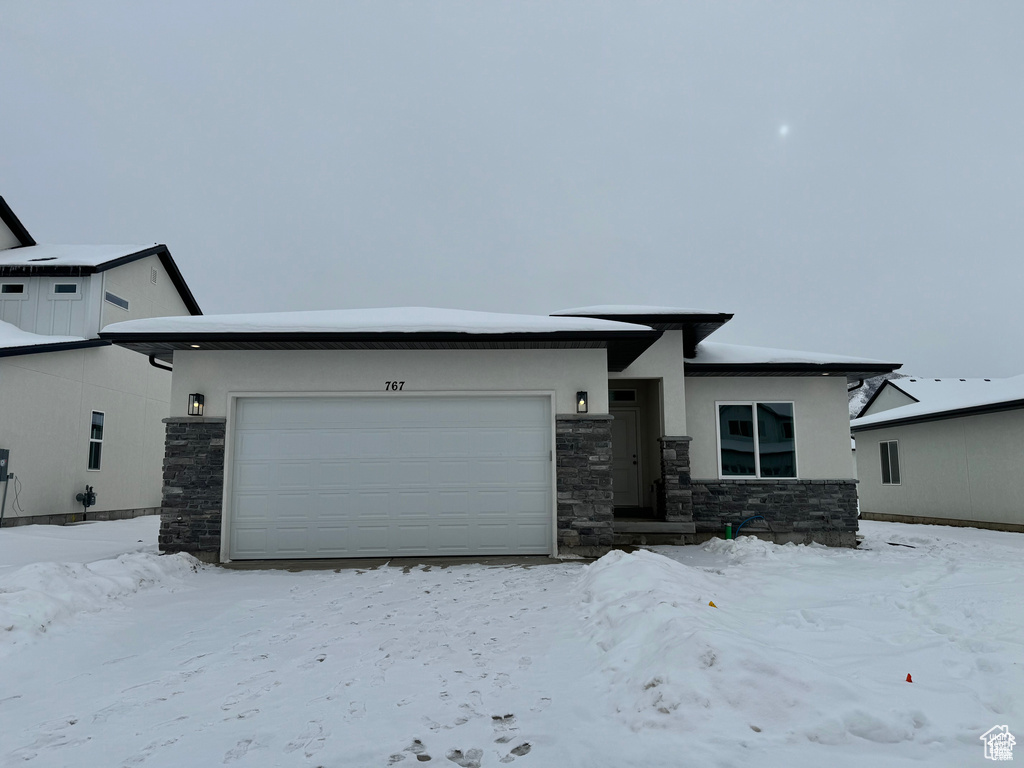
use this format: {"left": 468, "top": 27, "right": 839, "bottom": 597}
{"left": 160, "top": 416, "right": 227, "bottom": 562}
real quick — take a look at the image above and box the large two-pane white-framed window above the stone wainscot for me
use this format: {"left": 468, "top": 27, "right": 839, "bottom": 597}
{"left": 715, "top": 400, "right": 797, "bottom": 477}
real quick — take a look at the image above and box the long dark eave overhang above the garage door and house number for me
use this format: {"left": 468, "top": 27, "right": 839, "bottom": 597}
{"left": 99, "top": 331, "right": 662, "bottom": 373}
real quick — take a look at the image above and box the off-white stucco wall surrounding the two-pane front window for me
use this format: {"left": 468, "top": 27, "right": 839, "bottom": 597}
{"left": 686, "top": 376, "right": 859, "bottom": 480}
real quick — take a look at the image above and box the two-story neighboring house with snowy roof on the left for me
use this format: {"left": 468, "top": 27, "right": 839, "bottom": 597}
{"left": 0, "top": 198, "right": 200, "bottom": 526}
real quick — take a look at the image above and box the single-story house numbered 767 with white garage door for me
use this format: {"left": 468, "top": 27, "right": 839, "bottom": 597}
{"left": 100, "top": 306, "right": 898, "bottom": 561}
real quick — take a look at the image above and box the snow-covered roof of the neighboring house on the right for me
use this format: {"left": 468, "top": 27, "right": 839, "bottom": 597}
{"left": 850, "top": 375, "right": 1024, "bottom": 429}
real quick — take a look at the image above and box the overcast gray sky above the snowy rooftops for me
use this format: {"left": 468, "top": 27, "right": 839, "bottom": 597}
{"left": 0, "top": 0, "right": 1024, "bottom": 376}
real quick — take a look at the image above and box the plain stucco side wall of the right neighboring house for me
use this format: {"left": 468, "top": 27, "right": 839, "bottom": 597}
{"left": 857, "top": 411, "right": 1024, "bottom": 524}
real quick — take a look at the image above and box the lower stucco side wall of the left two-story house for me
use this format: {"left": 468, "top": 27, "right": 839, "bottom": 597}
{"left": 0, "top": 347, "right": 171, "bottom": 516}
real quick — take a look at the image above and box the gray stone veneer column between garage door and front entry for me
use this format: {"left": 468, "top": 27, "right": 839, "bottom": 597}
{"left": 555, "top": 414, "right": 614, "bottom": 557}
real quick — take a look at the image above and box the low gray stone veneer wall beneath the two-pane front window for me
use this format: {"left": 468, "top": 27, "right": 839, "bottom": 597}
{"left": 691, "top": 479, "right": 857, "bottom": 547}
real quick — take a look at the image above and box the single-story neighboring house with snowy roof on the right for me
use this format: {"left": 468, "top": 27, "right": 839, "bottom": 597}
{"left": 851, "top": 376, "right": 1024, "bottom": 531}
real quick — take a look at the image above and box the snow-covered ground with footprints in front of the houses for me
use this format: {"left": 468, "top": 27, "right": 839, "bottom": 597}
{"left": 0, "top": 518, "right": 1024, "bottom": 768}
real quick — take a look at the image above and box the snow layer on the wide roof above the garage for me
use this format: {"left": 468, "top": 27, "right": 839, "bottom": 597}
{"left": 102, "top": 307, "right": 651, "bottom": 334}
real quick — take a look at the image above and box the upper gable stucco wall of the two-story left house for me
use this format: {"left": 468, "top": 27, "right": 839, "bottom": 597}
{"left": 97, "top": 256, "right": 190, "bottom": 328}
